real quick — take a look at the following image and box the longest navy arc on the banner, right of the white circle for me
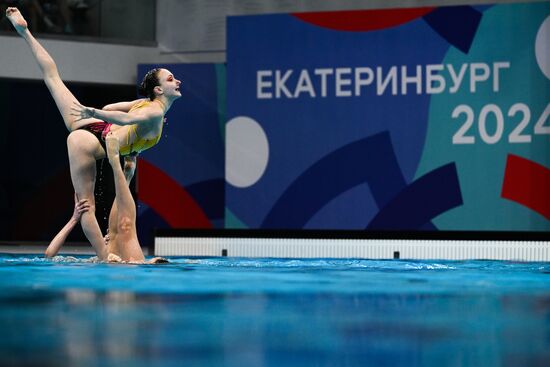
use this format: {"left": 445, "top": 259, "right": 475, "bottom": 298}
{"left": 261, "top": 131, "right": 406, "bottom": 228}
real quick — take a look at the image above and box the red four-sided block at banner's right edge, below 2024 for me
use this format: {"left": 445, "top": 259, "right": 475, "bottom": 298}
{"left": 501, "top": 154, "right": 550, "bottom": 220}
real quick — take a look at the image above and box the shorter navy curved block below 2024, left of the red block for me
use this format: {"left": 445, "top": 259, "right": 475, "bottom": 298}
{"left": 367, "top": 163, "right": 463, "bottom": 230}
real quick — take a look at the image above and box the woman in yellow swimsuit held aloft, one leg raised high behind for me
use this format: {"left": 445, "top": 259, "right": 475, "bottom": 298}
{"left": 6, "top": 7, "right": 181, "bottom": 260}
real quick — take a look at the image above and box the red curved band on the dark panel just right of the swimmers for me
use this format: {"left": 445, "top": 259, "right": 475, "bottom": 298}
{"left": 137, "top": 158, "right": 212, "bottom": 228}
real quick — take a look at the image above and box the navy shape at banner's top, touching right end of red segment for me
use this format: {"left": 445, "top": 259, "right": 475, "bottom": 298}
{"left": 424, "top": 6, "right": 482, "bottom": 54}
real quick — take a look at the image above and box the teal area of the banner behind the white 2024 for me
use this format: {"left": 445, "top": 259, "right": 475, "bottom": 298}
{"left": 416, "top": 2, "right": 550, "bottom": 231}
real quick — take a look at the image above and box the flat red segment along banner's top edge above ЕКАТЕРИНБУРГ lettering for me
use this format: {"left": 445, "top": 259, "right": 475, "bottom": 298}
{"left": 292, "top": 7, "right": 435, "bottom": 32}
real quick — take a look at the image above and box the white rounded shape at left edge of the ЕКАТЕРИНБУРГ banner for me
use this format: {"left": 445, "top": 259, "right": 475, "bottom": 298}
{"left": 225, "top": 116, "right": 269, "bottom": 188}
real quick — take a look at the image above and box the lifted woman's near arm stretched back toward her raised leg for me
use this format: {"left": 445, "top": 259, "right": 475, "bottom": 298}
{"left": 71, "top": 102, "right": 164, "bottom": 126}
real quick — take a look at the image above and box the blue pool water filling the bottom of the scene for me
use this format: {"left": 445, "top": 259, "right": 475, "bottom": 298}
{"left": 0, "top": 254, "right": 550, "bottom": 367}
